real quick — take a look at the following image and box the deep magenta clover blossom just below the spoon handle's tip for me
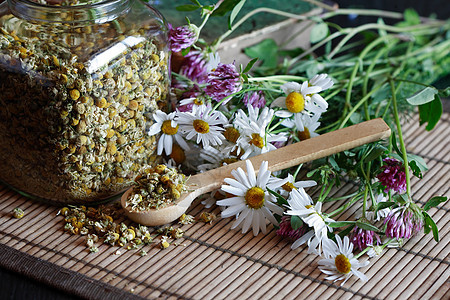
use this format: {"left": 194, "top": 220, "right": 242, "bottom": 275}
{"left": 377, "top": 158, "right": 406, "bottom": 193}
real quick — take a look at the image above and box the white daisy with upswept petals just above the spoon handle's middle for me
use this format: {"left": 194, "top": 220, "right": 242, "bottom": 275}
{"left": 234, "top": 106, "right": 287, "bottom": 159}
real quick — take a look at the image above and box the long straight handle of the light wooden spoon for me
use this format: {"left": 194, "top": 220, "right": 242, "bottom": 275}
{"left": 187, "top": 119, "right": 391, "bottom": 201}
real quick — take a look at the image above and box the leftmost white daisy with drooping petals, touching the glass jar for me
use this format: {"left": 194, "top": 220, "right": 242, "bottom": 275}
{"left": 148, "top": 110, "right": 189, "bottom": 155}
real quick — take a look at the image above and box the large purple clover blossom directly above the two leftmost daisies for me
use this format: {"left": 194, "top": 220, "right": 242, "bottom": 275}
{"left": 205, "top": 63, "right": 242, "bottom": 105}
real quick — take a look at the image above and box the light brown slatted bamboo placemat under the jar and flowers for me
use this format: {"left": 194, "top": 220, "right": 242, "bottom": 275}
{"left": 0, "top": 112, "right": 450, "bottom": 299}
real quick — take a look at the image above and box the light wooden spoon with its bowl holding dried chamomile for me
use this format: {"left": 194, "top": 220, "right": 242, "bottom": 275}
{"left": 121, "top": 119, "right": 391, "bottom": 226}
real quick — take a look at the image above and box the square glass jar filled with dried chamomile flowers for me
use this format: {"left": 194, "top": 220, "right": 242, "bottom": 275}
{"left": 0, "top": 0, "right": 170, "bottom": 204}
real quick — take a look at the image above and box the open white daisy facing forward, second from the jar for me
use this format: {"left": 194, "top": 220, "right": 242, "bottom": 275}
{"left": 178, "top": 105, "right": 227, "bottom": 147}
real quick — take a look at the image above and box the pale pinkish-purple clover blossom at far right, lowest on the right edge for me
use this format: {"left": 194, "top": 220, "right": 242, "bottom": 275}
{"left": 383, "top": 203, "right": 423, "bottom": 239}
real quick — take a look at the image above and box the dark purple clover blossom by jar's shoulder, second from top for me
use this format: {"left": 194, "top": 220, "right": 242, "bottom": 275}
{"left": 180, "top": 51, "right": 208, "bottom": 83}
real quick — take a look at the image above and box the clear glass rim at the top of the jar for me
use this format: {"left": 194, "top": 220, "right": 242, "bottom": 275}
{"left": 7, "top": 0, "right": 130, "bottom": 23}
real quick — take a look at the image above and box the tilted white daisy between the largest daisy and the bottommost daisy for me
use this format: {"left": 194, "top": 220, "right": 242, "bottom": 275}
{"left": 286, "top": 188, "right": 334, "bottom": 255}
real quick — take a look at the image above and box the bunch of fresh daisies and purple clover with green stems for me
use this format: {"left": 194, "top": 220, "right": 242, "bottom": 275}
{"left": 148, "top": 0, "right": 450, "bottom": 284}
